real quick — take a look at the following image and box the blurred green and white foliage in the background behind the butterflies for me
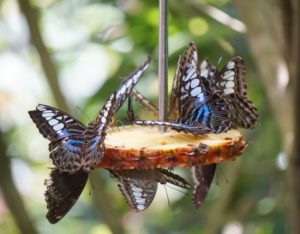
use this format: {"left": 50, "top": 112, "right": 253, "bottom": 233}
{"left": 0, "top": 0, "right": 287, "bottom": 234}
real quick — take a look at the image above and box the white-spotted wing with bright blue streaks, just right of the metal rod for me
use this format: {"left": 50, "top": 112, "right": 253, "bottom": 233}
{"left": 180, "top": 64, "right": 231, "bottom": 133}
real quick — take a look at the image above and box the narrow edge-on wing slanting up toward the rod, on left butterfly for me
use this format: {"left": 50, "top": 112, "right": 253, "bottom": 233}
{"left": 82, "top": 58, "right": 151, "bottom": 168}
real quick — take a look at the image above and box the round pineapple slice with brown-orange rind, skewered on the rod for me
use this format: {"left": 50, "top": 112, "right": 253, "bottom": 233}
{"left": 94, "top": 125, "right": 247, "bottom": 170}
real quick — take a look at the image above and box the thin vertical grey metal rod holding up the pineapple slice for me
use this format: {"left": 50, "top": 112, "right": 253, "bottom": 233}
{"left": 158, "top": 0, "right": 168, "bottom": 132}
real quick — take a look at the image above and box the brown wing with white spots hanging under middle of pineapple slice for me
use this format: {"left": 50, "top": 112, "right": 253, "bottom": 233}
{"left": 110, "top": 170, "right": 157, "bottom": 212}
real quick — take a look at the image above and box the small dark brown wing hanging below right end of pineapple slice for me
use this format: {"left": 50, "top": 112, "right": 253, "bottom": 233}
{"left": 191, "top": 164, "right": 216, "bottom": 208}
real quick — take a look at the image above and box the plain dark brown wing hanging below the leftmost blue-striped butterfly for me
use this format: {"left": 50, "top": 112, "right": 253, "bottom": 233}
{"left": 45, "top": 168, "right": 88, "bottom": 224}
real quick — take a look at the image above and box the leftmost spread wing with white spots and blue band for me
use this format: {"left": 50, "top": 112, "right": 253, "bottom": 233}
{"left": 28, "top": 104, "right": 86, "bottom": 173}
